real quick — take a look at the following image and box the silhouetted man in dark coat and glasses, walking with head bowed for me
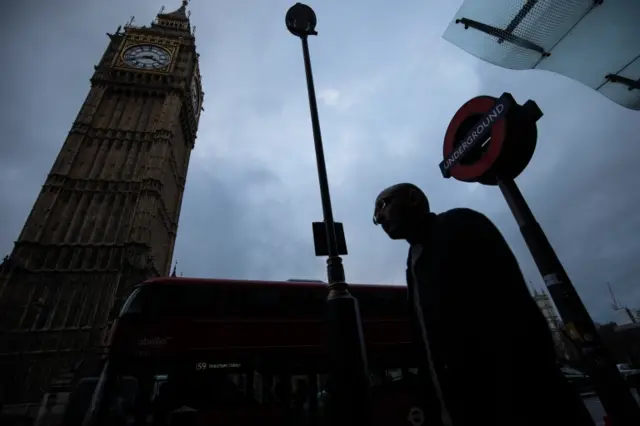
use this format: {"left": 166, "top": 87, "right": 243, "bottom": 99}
{"left": 374, "top": 183, "right": 593, "bottom": 426}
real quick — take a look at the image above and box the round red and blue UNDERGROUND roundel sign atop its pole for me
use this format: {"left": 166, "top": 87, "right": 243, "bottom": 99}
{"left": 440, "top": 93, "right": 542, "bottom": 185}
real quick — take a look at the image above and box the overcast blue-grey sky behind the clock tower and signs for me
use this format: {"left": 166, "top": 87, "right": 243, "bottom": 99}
{"left": 0, "top": 0, "right": 640, "bottom": 321}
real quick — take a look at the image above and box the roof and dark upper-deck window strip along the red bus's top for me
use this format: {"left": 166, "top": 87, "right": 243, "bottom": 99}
{"left": 122, "top": 277, "right": 407, "bottom": 318}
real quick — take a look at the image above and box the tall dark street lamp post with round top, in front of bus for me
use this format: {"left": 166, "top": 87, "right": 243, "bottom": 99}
{"left": 285, "top": 3, "right": 371, "bottom": 426}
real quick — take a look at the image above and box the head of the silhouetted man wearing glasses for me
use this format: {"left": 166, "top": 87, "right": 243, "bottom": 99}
{"left": 373, "top": 183, "right": 430, "bottom": 240}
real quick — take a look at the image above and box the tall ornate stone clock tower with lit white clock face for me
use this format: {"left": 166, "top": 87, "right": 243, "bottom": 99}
{"left": 0, "top": 0, "right": 203, "bottom": 420}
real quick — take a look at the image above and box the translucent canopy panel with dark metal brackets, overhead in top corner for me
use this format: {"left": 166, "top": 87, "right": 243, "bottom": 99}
{"left": 443, "top": 0, "right": 640, "bottom": 109}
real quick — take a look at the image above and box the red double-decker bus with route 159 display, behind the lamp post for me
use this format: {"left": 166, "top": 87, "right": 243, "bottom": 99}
{"left": 74, "top": 277, "right": 422, "bottom": 426}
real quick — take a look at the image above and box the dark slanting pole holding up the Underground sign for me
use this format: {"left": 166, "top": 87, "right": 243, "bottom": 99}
{"left": 498, "top": 179, "right": 640, "bottom": 426}
